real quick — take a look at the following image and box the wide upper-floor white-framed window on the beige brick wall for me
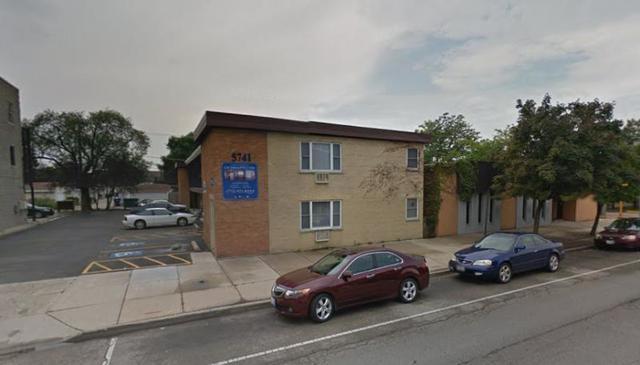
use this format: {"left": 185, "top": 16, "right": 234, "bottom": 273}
{"left": 300, "top": 142, "right": 342, "bottom": 171}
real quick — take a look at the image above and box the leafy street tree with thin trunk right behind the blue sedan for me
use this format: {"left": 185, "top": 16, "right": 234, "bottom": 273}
{"left": 496, "top": 95, "right": 593, "bottom": 232}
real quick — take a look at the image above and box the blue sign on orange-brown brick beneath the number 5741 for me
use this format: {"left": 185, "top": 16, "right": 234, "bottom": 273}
{"left": 222, "top": 162, "right": 258, "bottom": 200}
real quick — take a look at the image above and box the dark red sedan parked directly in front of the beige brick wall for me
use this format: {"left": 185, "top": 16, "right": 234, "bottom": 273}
{"left": 271, "top": 248, "right": 429, "bottom": 322}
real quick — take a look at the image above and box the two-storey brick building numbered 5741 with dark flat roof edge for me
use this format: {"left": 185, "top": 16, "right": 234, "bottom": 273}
{"left": 178, "top": 111, "right": 428, "bottom": 256}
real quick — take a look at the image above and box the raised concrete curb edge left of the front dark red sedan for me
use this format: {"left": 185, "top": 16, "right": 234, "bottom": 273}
{"left": 63, "top": 300, "right": 271, "bottom": 343}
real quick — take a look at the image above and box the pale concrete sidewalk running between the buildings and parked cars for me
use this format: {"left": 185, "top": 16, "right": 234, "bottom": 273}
{"left": 0, "top": 221, "right": 606, "bottom": 354}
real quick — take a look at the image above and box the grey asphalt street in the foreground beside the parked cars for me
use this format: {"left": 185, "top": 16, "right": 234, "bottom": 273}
{"left": 0, "top": 246, "right": 640, "bottom": 365}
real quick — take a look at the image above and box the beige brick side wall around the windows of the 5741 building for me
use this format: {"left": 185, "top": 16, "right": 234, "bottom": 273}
{"left": 267, "top": 133, "right": 422, "bottom": 252}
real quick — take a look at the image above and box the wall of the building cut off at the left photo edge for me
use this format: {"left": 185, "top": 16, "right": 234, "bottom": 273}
{"left": 0, "top": 78, "right": 25, "bottom": 231}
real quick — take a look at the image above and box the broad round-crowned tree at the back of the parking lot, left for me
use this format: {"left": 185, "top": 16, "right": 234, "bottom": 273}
{"left": 30, "top": 110, "right": 149, "bottom": 211}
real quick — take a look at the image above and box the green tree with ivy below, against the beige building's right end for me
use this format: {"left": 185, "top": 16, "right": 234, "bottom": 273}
{"left": 416, "top": 113, "right": 480, "bottom": 237}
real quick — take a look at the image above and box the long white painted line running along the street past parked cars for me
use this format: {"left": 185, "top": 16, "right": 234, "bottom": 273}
{"left": 211, "top": 260, "right": 640, "bottom": 365}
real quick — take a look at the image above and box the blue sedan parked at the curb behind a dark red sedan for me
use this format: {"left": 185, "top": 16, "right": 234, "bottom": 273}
{"left": 449, "top": 232, "right": 564, "bottom": 283}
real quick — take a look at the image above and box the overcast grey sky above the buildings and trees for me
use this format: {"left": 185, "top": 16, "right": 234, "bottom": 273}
{"left": 0, "top": 0, "right": 640, "bottom": 166}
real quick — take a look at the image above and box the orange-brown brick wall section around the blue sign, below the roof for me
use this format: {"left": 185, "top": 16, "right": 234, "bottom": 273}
{"left": 202, "top": 129, "right": 269, "bottom": 257}
